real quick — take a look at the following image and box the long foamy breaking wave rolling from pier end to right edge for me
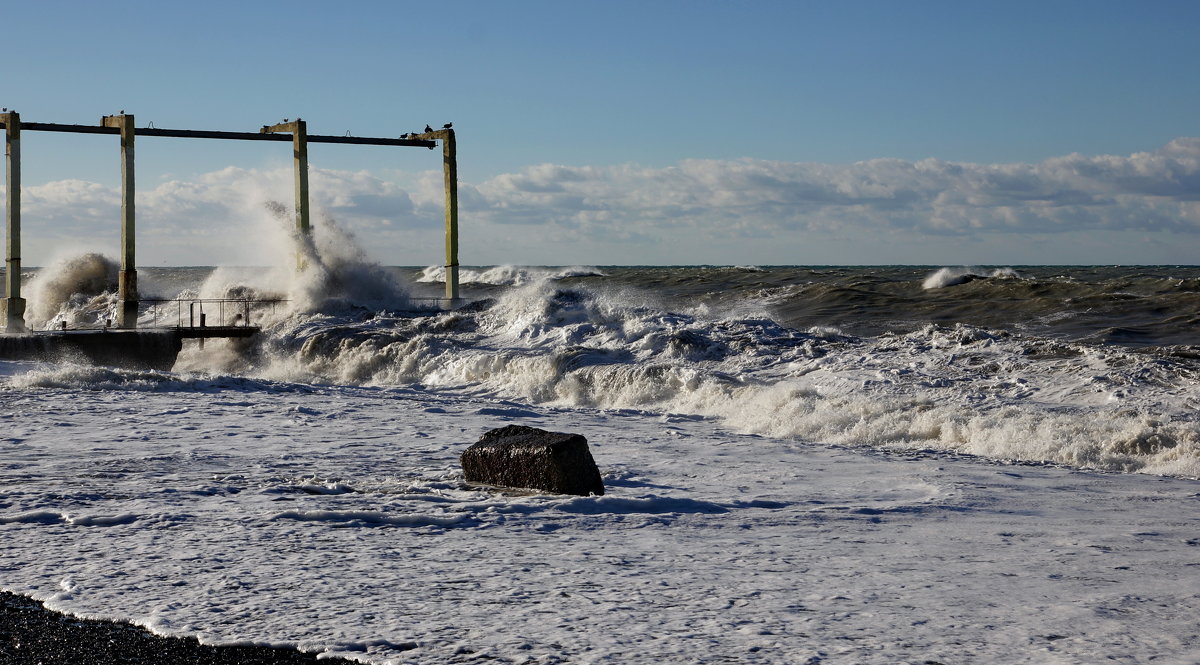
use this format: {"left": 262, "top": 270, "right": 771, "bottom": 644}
{"left": 164, "top": 278, "right": 1200, "bottom": 477}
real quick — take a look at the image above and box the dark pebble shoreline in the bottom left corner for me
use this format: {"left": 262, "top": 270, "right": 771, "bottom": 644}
{"left": 0, "top": 592, "right": 355, "bottom": 665}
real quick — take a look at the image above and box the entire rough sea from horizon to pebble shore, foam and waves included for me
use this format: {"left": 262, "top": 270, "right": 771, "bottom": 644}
{"left": 0, "top": 254, "right": 1200, "bottom": 664}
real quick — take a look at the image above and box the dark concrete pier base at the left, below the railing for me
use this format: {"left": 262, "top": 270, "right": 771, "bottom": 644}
{"left": 0, "top": 330, "right": 184, "bottom": 370}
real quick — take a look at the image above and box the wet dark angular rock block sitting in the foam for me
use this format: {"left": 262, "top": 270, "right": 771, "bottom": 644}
{"left": 461, "top": 425, "right": 604, "bottom": 496}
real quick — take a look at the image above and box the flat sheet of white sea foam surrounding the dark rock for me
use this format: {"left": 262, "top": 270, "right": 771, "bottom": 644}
{"left": 0, "top": 374, "right": 1200, "bottom": 665}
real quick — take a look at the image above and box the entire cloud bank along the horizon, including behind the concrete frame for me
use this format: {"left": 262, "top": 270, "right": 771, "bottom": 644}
{"left": 2, "top": 138, "right": 1200, "bottom": 265}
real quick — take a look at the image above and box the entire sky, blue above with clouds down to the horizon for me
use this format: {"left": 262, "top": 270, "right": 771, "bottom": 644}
{"left": 0, "top": 1, "right": 1200, "bottom": 264}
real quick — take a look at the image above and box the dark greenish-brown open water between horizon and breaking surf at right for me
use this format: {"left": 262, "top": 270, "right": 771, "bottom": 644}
{"left": 436, "top": 265, "right": 1200, "bottom": 347}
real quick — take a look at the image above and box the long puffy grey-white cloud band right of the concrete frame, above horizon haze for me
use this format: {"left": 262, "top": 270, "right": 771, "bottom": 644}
{"left": 460, "top": 138, "right": 1200, "bottom": 239}
